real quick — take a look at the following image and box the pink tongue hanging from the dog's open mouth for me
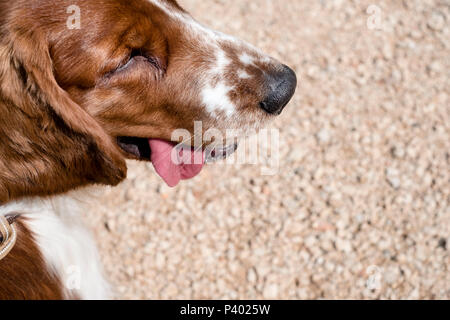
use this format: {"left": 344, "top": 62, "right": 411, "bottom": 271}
{"left": 149, "top": 139, "right": 205, "bottom": 187}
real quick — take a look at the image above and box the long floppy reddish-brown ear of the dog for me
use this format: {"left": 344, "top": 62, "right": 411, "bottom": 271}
{"left": 0, "top": 28, "right": 126, "bottom": 203}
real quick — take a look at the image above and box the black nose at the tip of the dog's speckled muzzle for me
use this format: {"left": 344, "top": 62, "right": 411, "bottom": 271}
{"left": 259, "top": 66, "right": 297, "bottom": 115}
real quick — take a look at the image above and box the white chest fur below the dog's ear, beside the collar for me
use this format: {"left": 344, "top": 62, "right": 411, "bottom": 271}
{"left": 0, "top": 192, "right": 110, "bottom": 299}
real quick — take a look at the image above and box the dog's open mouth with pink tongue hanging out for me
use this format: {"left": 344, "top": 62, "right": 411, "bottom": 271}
{"left": 117, "top": 137, "right": 238, "bottom": 187}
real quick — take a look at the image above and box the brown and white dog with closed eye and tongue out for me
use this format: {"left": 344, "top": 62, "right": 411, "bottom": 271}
{"left": 0, "top": 0, "right": 297, "bottom": 299}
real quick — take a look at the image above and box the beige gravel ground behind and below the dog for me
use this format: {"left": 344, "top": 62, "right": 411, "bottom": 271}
{"left": 82, "top": 0, "right": 450, "bottom": 299}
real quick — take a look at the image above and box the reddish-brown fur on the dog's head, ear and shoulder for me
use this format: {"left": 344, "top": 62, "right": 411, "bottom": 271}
{"left": 0, "top": 0, "right": 288, "bottom": 299}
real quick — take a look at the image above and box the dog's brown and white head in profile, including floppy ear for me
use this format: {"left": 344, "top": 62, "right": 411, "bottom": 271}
{"left": 0, "top": 0, "right": 296, "bottom": 200}
